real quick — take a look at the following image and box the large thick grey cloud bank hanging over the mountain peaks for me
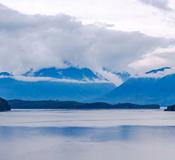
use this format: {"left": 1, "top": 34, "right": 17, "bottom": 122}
{"left": 0, "top": 3, "right": 171, "bottom": 72}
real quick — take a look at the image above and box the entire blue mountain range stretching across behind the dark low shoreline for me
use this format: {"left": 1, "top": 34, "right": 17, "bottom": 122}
{"left": 0, "top": 66, "right": 175, "bottom": 106}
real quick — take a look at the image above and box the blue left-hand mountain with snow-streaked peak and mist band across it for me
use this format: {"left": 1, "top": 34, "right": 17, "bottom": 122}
{"left": 0, "top": 67, "right": 115, "bottom": 101}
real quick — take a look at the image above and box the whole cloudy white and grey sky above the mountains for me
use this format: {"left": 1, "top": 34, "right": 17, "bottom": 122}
{"left": 0, "top": 0, "right": 175, "bottom": 84}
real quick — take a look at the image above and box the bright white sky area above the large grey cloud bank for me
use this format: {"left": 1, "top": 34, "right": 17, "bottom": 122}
{"left": 0, "top": 0, "right": 175, "bottom": 38}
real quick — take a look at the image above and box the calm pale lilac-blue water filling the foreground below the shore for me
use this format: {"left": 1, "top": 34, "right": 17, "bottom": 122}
{"left": 0, "top": 110, "right": 175, "bottom": 160}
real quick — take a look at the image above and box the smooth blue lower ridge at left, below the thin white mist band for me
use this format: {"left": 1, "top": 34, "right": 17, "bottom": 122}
{"left": 0, "top": 78, "right": 115, "bottom": 101}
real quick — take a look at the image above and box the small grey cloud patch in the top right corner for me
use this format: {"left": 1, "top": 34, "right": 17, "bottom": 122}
{"left": 140, "top": 0, "right": 172, "bottom": 11}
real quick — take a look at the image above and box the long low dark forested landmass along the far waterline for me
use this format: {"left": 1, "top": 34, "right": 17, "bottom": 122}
{"left": 9, "top": 100, "right": 160, "bottom": 109}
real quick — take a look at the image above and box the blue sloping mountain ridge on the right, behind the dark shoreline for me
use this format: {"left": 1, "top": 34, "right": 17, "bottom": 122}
{"left": 101, "top": 74, "right": 175, "bottom": 106}
